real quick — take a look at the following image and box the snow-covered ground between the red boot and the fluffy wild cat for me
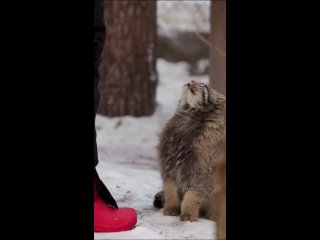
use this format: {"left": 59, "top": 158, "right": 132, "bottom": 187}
{"left": 94, "top": 59, "right": 214, "bottom": 239}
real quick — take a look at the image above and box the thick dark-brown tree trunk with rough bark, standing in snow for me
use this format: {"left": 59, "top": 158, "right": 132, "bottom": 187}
{"left": 98, "top": 0, "right": 158, "bottom": 117}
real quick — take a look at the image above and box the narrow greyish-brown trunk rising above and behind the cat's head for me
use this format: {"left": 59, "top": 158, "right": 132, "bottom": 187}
{"left": 210, "top": 0, "right": 226, "bottom": 95}
